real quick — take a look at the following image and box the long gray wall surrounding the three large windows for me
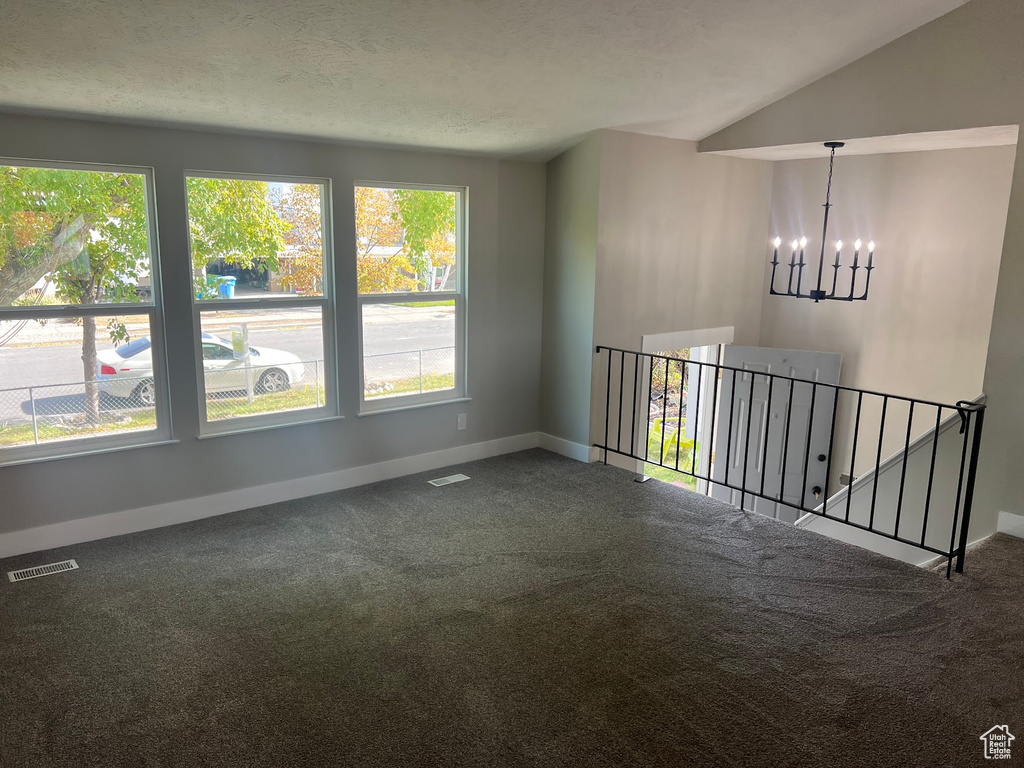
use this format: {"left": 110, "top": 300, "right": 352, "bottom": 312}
{"left": 0, "top": 116, "right": 545, "bottom": 532}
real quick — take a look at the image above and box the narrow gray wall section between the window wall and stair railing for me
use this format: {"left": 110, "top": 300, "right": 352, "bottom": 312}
{"left": 541, "top": 134, "right": 601, "bottom": 445}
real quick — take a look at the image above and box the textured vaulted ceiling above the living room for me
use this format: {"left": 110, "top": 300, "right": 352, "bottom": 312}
{"left": 0, "top": 0, "right": 963, "bottom": 159}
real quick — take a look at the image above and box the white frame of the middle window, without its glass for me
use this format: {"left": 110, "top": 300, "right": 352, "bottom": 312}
{"left": 181, "top": 169, "right": 341, "bottom": 439}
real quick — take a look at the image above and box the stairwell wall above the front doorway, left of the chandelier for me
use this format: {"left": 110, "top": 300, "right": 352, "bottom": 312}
{"left": 594, "top": 131, "right": 772, "bottom": 349}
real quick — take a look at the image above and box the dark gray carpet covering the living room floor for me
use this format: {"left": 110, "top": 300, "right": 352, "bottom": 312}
{"left": 0, "top": 451, "right": 1024, "bottom": 768}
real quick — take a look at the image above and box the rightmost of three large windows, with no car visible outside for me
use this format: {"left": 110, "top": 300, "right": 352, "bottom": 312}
{"left": 355, "top": 184, "right": 466, "bottom": 413}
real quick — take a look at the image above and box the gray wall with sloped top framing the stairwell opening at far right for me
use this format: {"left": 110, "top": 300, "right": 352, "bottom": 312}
{"left": 700, "top": 0, "right": 1024, "bottom": 536}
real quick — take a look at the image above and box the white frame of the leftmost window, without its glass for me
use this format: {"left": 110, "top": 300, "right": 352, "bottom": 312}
{"left": 0, "top": 157, "right": 173, "bottom": 466}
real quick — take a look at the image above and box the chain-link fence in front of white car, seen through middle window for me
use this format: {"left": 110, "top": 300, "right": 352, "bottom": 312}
{"left": 205, "top": 360, "right": 325, "bottom": 421}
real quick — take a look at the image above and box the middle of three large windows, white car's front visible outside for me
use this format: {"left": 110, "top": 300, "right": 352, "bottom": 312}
{"left": 185, "top": 174, "right": 338, "bottom": 433}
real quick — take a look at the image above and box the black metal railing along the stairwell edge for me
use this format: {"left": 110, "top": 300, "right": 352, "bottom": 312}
{"left": 595, "top": 346, "right": 985, "bottom": 577}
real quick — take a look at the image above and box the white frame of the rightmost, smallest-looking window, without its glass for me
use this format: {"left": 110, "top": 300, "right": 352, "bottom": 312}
{"left": 352, "top": 180, "right": 469, "bottom": 416}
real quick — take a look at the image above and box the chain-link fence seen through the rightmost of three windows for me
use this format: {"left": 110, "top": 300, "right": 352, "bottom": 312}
{"left": 362, "top": 347, "right": 455, "bottom": 399}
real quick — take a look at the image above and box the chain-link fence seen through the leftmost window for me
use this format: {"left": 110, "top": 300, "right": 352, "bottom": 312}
{"left": 0, "top": 378, "right": 157, "bottom": 447}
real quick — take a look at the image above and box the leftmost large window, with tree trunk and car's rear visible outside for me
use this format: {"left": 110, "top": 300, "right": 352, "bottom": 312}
{"left": 0, "top": 161, "right": 170, "bottom": 463}
